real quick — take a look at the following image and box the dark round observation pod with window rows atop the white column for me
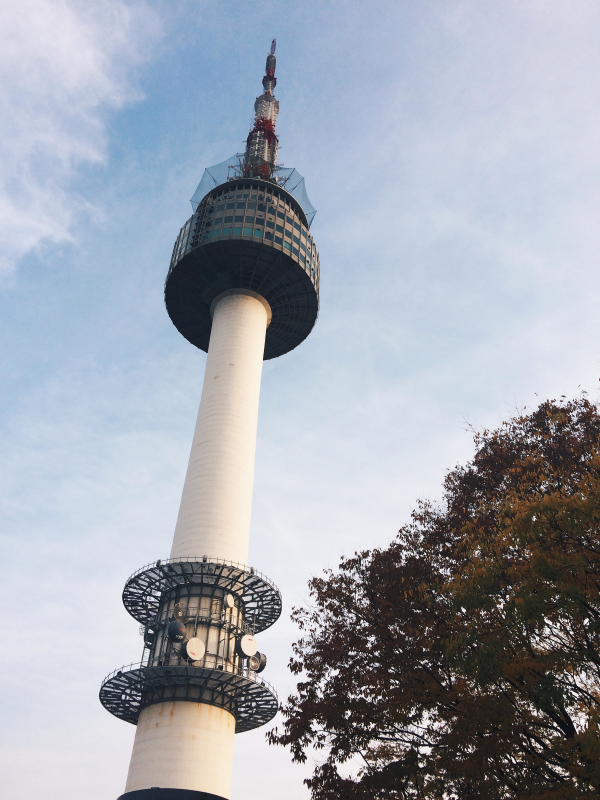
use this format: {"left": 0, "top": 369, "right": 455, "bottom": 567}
{"left": 165, "top": 178, "right": 319, "bottom": 359}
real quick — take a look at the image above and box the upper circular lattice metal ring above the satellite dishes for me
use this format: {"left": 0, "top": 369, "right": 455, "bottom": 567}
{"left": 123, "top": 557, "right": 282, "bottom": 633}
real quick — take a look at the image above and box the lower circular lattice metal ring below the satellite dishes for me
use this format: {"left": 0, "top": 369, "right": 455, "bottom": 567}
{"left": 100, "top": 664, "right": 279, "bottom": 733}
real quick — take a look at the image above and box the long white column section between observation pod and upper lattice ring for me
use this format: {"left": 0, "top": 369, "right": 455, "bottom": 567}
{"left": 171, "top": 290, "right": 271, "bottom": 564}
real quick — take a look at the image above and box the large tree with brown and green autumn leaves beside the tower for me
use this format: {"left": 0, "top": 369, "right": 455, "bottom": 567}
{"left": 269, "top": 396, "right": 600, "bottom": 800}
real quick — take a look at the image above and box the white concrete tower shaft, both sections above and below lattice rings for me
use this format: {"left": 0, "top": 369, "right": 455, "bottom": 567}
{"left": 125, "top": 290, "right": 271, "bottom": 798}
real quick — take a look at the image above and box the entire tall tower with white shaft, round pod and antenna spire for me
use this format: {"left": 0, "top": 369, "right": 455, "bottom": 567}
{"left": 100, "top": 40, "right": 319, "bottom": 800}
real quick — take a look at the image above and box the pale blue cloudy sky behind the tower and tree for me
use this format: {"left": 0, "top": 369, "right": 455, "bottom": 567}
{"left": 0, "top": 0, "right": 600, "bottom": 800}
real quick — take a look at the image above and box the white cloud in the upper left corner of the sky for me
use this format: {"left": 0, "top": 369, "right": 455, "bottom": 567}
{"left": 0, "top": 0, "right": 158, "bottom": 276}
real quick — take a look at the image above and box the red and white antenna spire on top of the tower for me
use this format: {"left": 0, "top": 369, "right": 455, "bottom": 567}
{"left": 243, "top": 39, "right": 279, "bottom": 181}
